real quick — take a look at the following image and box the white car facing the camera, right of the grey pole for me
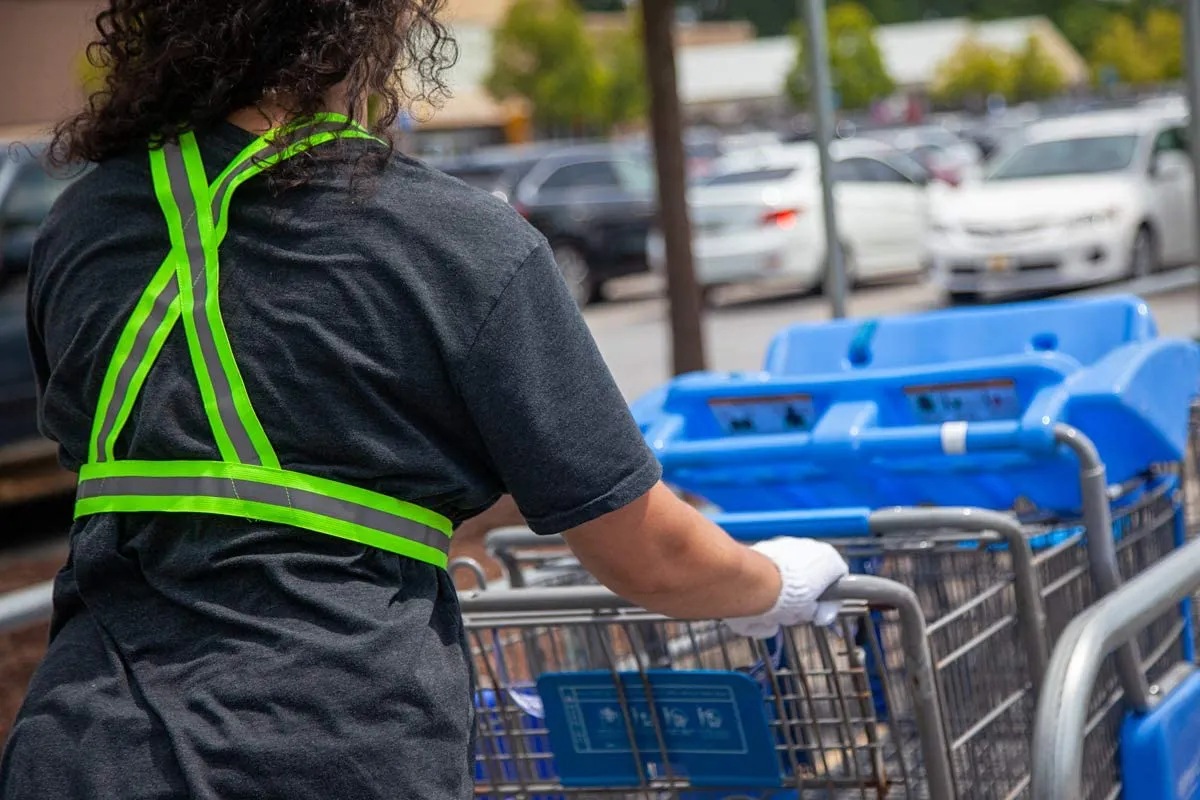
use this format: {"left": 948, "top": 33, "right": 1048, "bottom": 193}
{"left": 926, "top": 110, "right": 1196, "bottom": 301}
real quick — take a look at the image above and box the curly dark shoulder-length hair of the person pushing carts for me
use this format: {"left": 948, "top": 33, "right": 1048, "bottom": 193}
{"left": 50, "top": 0, "right": 457, "bottom": 179}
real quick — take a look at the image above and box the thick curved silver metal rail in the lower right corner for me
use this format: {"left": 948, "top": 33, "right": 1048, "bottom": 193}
{"left": 1032, "top": 527, "right": 1200, "bottom": 800}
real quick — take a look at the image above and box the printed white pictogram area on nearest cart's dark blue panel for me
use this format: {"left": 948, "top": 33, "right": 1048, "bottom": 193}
{"left": 559, "top": 685, "right": 749, "bottom": 756}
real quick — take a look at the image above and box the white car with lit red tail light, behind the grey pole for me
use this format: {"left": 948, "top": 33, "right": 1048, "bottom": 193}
{"left": 647, "top": 142, "right": 929, "bottom": 297}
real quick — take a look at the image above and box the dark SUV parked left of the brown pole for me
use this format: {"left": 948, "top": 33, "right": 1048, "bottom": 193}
{"left": 439, "top": 145, "right": 655, "bottom": 306}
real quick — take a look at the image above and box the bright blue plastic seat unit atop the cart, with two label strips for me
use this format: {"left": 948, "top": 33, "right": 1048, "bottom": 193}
{"left": 632, "top": 297, "right": 1200, "bottom": 512}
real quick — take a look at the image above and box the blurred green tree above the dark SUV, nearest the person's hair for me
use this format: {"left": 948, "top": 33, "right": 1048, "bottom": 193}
{"left": 486, "top": 0, "right": 604, "bottom": 128}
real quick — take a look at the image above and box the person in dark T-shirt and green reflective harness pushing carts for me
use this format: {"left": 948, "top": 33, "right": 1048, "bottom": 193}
{"left": 0, "top": 0, "right": 846, "bottom": 800}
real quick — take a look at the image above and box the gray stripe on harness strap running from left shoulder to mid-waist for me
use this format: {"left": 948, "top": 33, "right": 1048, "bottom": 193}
{"left": 163, "top": 143, "right": 263, "bottom": 465}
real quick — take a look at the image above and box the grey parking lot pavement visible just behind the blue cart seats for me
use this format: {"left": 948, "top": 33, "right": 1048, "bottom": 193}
{"left": 584, "top": 267, "right": 1200, "bottom": 401}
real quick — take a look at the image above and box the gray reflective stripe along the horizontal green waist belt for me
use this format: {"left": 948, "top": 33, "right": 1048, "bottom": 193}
{"left": 76, "top": 476, "right": 450, "bottom": 553}
